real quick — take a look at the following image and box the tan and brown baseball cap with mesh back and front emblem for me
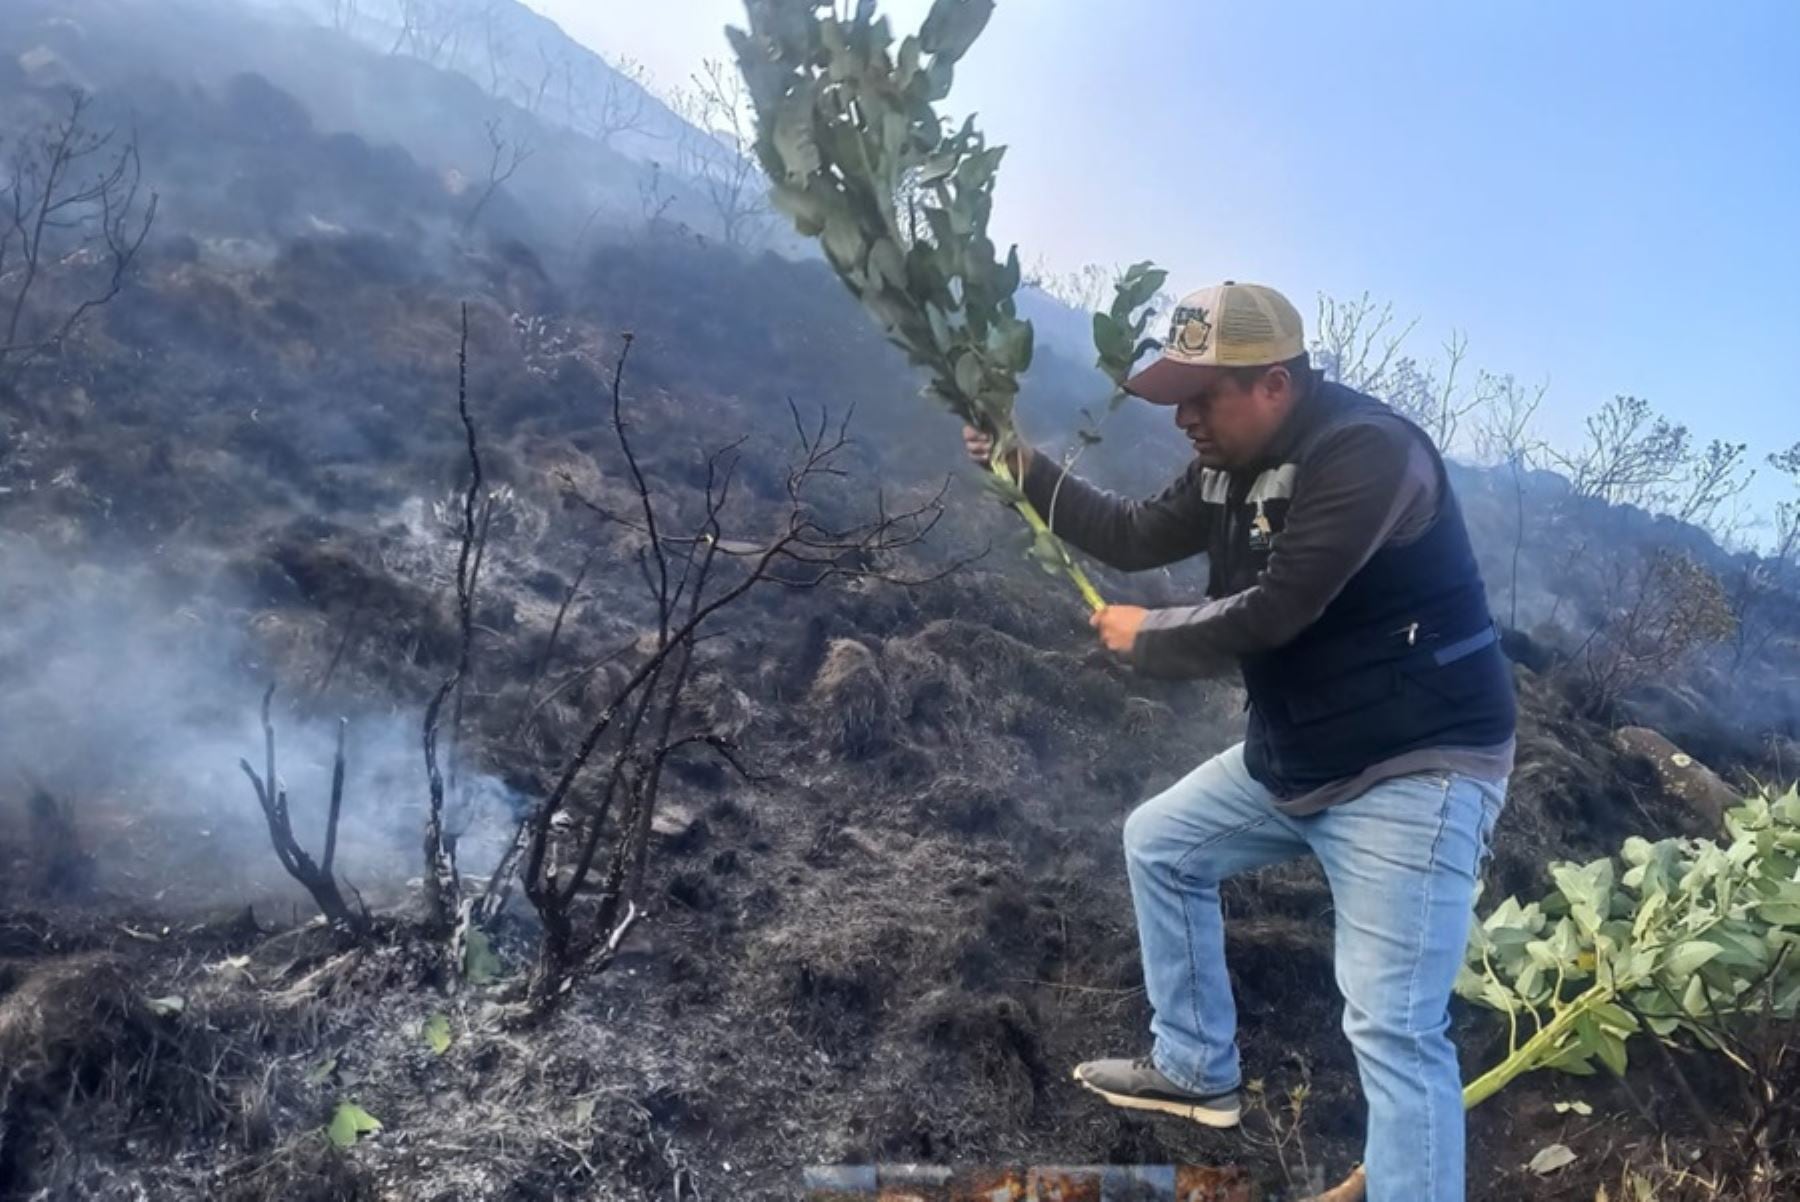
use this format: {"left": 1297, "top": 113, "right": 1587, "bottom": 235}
{"left": 1125, "top": 279, "right": 1307, "bottom": 405}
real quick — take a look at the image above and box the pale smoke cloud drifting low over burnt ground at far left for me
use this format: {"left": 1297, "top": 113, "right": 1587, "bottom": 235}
{"left": 0, "top": 538, "right": 518, "bottom": 912}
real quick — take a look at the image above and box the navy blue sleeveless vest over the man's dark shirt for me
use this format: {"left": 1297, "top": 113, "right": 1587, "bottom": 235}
{"left": 1213, "top": 383, "right": 1516, "bottom": 797}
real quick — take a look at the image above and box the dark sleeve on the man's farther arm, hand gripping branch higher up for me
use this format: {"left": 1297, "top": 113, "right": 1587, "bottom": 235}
{"left": 1022, "top": 453, "right": 1213, "bottom": 572}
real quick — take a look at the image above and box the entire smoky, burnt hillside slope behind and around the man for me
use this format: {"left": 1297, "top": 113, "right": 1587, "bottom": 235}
{"left": 0, "top": 0, "right": 1800, "bottom": 1198}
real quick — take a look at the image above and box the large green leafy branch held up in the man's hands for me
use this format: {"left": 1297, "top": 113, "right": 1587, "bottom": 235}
{"left": 727, "top": 0, "right": 1165, "bottom": 608}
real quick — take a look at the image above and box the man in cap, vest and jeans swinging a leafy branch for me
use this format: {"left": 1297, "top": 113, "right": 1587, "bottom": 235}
{"left": 965, "top": 281, "right": 1514, "bottom": 1202}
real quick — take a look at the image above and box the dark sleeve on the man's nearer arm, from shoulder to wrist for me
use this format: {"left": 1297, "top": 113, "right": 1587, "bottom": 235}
{"left": 1132, "top": 421, "right": 1438, "bottom": 677}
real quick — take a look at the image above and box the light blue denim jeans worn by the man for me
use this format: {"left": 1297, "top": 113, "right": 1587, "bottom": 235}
{"left": 1125, "top": 745, "right": 1505, "bottom": 1202}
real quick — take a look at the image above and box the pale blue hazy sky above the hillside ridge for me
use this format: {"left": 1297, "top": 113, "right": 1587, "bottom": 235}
{"left": 529, "top": 0, "right": 1800, "bottom": 521}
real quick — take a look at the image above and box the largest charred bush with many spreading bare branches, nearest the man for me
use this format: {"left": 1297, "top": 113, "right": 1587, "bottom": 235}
{"left": 475, "top": 336, "right": 979, "bottom": 1015}
